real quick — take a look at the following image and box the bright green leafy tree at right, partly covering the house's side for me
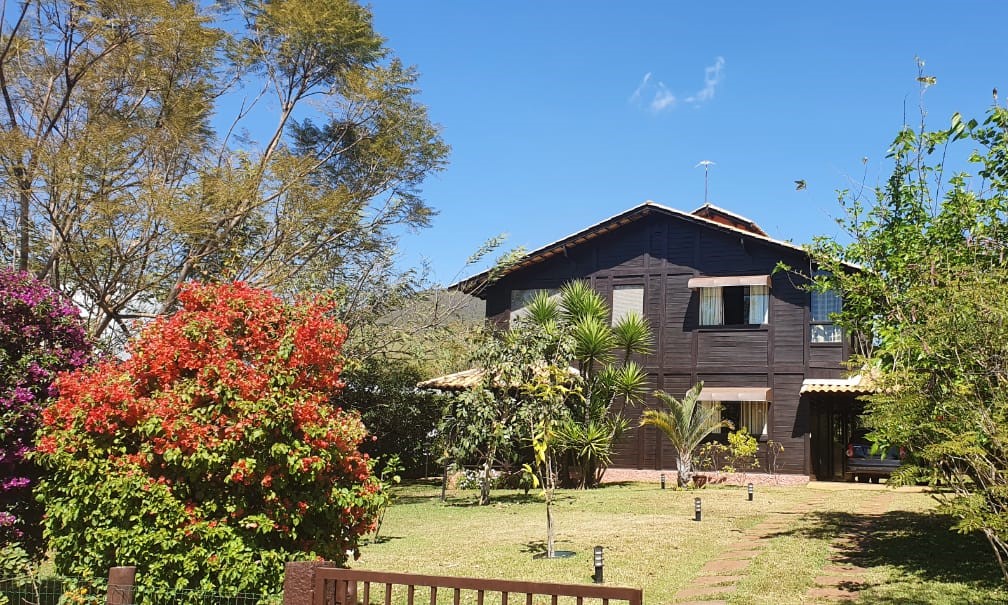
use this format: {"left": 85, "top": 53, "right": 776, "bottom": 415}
{"left": 812, "top": 72, "right": 1008, "bottom": 580}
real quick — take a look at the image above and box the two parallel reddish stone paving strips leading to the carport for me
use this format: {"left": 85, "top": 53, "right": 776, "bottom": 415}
{"left": 675, "top": 493, "right": 892, "bottom": 605}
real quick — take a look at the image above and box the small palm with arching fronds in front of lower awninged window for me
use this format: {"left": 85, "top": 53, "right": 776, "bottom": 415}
{"left": 640, "top": 381, "right": 734, "bottom": 487}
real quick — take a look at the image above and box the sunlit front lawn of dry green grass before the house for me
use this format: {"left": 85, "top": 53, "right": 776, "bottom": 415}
{"left": 354, "top": 482, "right": 1008, "bottom": 605}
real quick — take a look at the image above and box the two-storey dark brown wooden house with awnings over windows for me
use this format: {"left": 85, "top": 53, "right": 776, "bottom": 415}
{"left": 456, "top": 202, "right": 865, "bottom": 479}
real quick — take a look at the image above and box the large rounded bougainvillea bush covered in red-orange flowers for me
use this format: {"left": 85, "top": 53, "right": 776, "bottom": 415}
{"left": 38, "top": 283, "right": 383, "bottom": 592}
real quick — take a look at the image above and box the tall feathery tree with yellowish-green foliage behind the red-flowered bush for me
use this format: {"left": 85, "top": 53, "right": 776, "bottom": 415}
{"left": 0, "top": 0, "right": 448, "bottom": 344}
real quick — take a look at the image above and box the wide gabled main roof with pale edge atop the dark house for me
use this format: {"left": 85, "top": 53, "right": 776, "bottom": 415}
{"left": 457, "top": 200, "right": 807, "bottom": 297}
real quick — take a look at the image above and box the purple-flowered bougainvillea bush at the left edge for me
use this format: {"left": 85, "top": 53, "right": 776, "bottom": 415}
{"left": 0, "top": 268, "right": 92, "bottom": 558}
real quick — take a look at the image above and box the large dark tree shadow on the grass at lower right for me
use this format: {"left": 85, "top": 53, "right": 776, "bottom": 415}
{"left": 779, "top": 510, "right": 1004, "bottom": 592}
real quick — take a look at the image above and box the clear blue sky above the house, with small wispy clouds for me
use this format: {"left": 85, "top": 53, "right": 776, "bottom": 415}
{"left": 371, "top": 0, "right": 1008, "bottom": 282}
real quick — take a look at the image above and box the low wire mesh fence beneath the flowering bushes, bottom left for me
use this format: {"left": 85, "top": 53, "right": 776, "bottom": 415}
{"left": 0, "top": 576, "right": 283, "bottom": 605}
